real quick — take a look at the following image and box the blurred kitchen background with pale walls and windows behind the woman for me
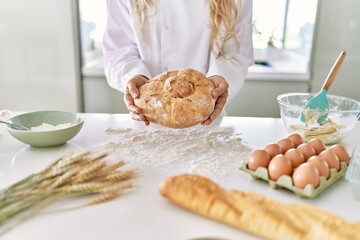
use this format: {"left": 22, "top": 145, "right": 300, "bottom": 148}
{"left": 0, "top": 0, "right": 360, "bottom": 117}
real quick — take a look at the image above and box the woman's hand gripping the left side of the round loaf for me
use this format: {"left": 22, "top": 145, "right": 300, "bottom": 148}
{"left": 124, "top": 75, "right": 150, "bottom": 125}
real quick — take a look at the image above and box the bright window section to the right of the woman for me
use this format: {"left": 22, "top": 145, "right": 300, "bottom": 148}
{"left": 250, "top": 0, "right": 318, "bottom": 78}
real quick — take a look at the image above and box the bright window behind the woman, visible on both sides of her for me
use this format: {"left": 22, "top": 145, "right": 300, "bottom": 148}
{"left": 79, "top": 0, "right": 318, "bottom": 78}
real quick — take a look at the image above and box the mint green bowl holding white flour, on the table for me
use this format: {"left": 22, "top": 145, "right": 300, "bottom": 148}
{"left": 6, "top": 111, "right": 84, "bottom": 147}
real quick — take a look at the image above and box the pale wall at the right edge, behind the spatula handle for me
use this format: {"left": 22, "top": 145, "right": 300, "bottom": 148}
{"left": 311, "top": 0, "right": 360, "bottom": 101}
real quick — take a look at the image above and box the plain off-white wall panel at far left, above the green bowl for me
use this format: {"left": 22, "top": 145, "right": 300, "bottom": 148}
{"left": 0, "top": 0, "right": 82, "bottom": 111}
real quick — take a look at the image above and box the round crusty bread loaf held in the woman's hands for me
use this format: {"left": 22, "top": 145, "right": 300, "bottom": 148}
{"left": 134, "top": 69, "right": 215, "bottom": 128}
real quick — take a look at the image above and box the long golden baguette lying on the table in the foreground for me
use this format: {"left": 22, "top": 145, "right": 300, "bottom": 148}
{"left": 159, "top": 174, "right": 360, "bottom": 239}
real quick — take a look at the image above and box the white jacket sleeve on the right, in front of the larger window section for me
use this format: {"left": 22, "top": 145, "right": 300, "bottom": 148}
{"left": 206, "top": 0, "right": 254, "bottom": 100}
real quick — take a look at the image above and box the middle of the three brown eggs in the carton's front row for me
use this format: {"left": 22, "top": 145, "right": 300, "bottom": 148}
{"left": 268, "top": 154, "right": 293, "bottom": 181}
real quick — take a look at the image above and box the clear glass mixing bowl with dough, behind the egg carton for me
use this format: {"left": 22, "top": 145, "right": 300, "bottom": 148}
{"left": 277, "top": 93, "right": 360, "bottom": 145}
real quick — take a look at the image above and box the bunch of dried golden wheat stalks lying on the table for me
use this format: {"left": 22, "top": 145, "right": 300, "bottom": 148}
{"left": 0, "top": 148, "right": 136, "bottom": 236}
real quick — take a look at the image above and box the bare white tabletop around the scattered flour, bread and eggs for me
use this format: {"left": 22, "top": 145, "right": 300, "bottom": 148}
{"left": 0, "top": 114, "right": 360, "bottom": 240}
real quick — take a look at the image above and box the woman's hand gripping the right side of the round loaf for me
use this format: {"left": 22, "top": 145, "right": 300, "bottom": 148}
{"left": 201, "top": 76, "right": 229, "bottom": 125}
